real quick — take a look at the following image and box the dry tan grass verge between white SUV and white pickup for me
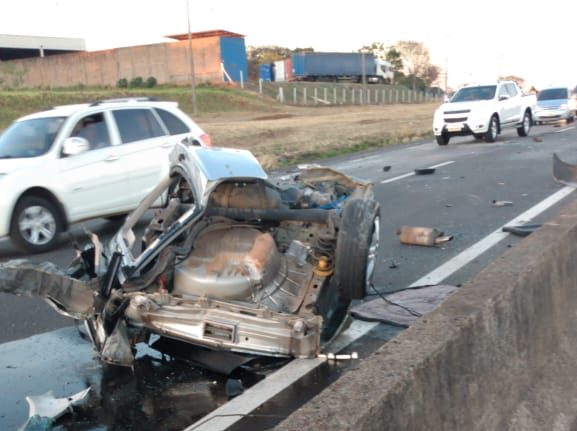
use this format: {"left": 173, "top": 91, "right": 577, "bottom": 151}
{"left": 197, "top": 103, "right": 438, "bottom": 168}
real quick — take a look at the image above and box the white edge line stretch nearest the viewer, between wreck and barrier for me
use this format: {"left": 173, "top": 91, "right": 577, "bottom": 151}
{"left": 185, "top": 320, "right": 379, "bottom": 431}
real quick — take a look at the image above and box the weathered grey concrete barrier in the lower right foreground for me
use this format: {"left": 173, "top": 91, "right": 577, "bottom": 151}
{"left": 275, "top": 197, "right": 577, "bottom": 431}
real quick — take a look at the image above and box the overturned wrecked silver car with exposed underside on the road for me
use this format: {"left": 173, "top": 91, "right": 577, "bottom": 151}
{"left": 0, "top": 145, "right": 380, "bottom": 366}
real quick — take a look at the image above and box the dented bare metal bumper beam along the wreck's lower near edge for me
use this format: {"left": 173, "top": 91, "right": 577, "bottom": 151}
{"left": 126, "top": 294, "right": 322, "bottom": 358}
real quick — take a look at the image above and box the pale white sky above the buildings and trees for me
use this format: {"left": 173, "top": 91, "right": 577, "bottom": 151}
{"left": 0, "top": 0, "right": 577, "bottom": 88}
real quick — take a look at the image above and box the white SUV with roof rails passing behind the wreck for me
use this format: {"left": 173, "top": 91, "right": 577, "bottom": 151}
{"left": 0, "top": 98, "right": 211, "bottom": 252}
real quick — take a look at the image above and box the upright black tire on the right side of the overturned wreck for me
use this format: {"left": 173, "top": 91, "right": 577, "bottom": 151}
{"left": 333, "top": 199, "right": 380, "bottom": 300}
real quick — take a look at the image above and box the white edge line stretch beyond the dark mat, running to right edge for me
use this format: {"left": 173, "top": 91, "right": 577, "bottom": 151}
{"left": 410, "top": 187, "right": 575, "bottom": 287}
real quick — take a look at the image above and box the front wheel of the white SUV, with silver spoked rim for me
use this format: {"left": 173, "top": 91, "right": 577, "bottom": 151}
{"left": 10, "top": 196, "right": 64, "bottom": 253}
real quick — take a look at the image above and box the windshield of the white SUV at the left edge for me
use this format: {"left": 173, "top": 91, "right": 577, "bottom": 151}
{"left": 0, "top": 117, "right": 65, "bottom": 159}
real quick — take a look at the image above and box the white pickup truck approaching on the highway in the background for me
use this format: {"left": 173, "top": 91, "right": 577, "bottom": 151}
{"left": 433, "top": 81, "right": 536, "bottom": 145}
